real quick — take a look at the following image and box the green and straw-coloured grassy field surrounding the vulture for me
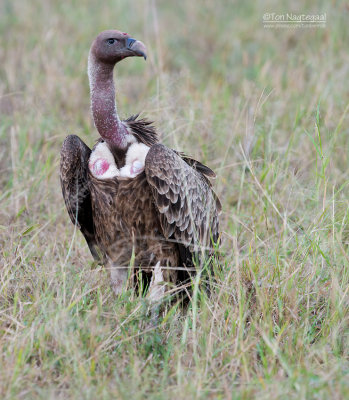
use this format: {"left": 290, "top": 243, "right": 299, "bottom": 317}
{"left": 0, "top": 0, "right": 349, "bottom": 400}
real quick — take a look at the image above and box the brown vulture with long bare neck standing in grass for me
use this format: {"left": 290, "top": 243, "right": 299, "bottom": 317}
{"left": 60, "top": 30, "right": 221, "bottom": 297}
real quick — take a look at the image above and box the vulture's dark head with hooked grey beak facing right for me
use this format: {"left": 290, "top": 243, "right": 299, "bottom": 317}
{"left": 91, "top": 30, "right": 147, "bottom": 65}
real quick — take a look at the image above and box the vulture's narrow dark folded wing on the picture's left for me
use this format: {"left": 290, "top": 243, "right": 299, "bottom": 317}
{"left": 60, "top": 135, "right": 100, "bottom": 261}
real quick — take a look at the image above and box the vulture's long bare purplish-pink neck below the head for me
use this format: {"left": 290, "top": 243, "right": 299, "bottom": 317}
{"left": 88, "top": 53, "right": 128, "bottom": 149}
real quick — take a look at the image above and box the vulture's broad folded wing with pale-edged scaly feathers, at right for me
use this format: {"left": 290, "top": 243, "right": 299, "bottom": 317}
{"left": 144, "top": 144, "right": 221, "bottom": 263}
